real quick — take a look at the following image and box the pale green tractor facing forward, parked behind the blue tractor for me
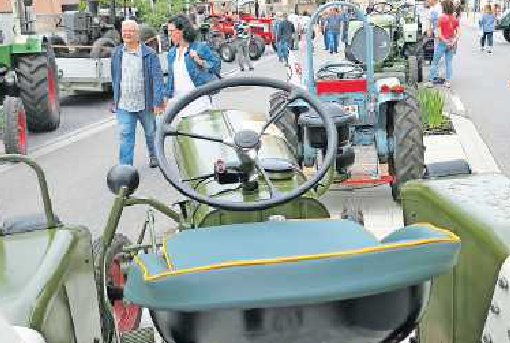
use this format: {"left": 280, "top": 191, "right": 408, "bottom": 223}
{"left": 345, "top": 1, "right": 423, "bottom": 86}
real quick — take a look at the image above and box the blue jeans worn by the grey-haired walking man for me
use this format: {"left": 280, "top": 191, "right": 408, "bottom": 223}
{"left": 117, "top": 108, "right": 156, "bottom": 165}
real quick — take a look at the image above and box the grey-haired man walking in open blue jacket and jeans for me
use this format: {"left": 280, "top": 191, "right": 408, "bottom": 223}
{"left": 111, "top": 20, "right": 165, "bottom": 168}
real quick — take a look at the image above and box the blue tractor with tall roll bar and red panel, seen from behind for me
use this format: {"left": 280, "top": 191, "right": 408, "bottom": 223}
{"left": 271, "top": 1, "right": 424, "bottom": 200}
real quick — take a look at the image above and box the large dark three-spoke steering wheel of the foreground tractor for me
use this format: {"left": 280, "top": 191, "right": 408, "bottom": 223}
{"left": 155, "top": 77, "right": 337, "bottom": 211}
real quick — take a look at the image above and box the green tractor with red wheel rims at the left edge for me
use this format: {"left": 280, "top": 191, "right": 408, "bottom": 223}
{"left": 0, "top": 0, "right": 60, "bottom": 134}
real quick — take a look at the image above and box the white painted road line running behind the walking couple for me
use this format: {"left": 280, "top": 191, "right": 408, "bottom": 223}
{"left": 0, "top": 55, "right": 275, "bottom": 173}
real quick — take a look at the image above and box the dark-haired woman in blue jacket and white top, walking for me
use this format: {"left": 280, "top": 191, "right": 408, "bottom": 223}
{"left": 167, "top": 14, "right": 221, "bottom": 115}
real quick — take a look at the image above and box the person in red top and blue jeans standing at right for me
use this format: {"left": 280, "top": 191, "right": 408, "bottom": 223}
{"left": 427, "top": 0, "right": 459, "bottom": 88}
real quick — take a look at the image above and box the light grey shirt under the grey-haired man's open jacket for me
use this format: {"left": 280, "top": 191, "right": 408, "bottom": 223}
{"left": 118, "top": 46, "right": 145, "bottom": 112}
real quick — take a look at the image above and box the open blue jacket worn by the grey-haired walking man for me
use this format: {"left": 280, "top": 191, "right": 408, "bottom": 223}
{"left": 111, "top": 44, "right": 165, "bottom": 112}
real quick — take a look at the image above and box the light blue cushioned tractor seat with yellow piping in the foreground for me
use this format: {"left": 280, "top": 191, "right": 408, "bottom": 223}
{"left": 124, "top": 219, "right": 460, "bottom": 312}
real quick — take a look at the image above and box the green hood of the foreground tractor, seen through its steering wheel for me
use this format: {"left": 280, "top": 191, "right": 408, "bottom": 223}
{"left": 173, "top": 110, "right": 329, "bottom": 227}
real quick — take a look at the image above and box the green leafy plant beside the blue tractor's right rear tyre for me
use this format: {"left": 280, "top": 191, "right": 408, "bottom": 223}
{"left": 418, "top": 88, "right": 446, "bottom": 129}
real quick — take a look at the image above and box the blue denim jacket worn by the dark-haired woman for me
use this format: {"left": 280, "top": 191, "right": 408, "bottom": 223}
{"left": 167, "top": 42, "right": 221, "bottom": 98}
